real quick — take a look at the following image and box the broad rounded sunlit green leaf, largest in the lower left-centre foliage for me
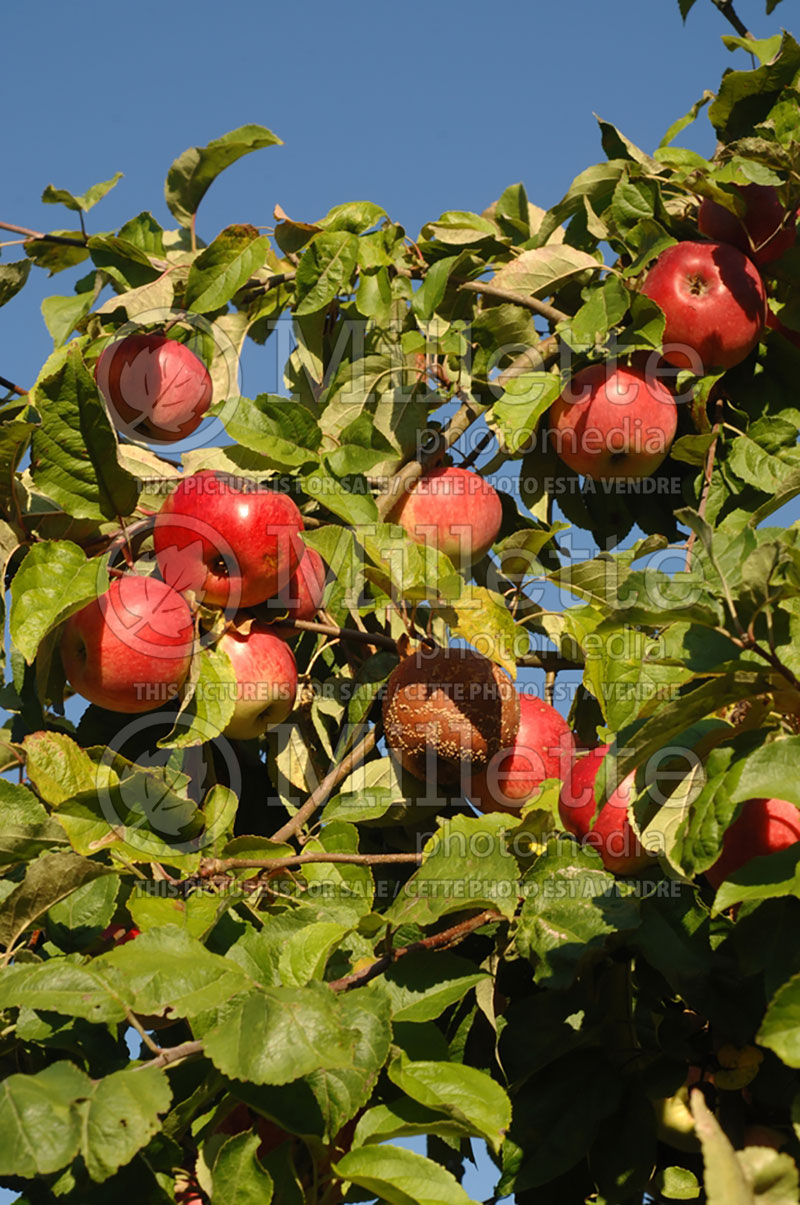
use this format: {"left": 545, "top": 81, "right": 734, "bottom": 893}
{"left": 200, "top": 983, "right": 357, "bottom": 1085}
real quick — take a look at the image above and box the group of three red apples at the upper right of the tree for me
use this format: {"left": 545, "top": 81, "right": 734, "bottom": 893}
{"left": 549, "top": 184, "right": 800, "bottom": 480}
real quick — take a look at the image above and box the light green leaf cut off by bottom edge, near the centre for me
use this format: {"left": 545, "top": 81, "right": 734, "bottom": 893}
{"left": 334, "top": 1145, "right": 477, "bottom": 1205}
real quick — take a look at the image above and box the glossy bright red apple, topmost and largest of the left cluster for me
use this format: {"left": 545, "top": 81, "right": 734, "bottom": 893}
{"left": 153, "top": 469, "right": 305, "bottom": 607}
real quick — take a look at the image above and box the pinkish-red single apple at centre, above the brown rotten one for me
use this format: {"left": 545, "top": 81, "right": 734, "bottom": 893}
{"left": 389, "top": 468, "right": 502, "bottom": 565}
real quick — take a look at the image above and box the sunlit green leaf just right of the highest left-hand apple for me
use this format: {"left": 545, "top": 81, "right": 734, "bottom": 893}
{"left": 215, "top": 393, "right": 322, "bottom": 469}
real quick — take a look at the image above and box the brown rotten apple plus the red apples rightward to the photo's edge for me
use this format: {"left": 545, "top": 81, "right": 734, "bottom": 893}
{"left": 383, "top": 647, "right": 800, "bottom": 888}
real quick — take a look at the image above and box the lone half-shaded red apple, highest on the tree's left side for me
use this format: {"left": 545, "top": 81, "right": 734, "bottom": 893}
{"left": 94, "top": 335, "right": 212, "bottom": 443}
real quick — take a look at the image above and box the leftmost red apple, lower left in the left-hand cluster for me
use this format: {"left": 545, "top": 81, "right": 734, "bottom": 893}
{"left": 61, "top": 574, "right": 194, "bottom": 712}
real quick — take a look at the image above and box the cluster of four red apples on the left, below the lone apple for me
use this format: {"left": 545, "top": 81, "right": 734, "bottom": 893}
{"left": 61, "top": 470, "right": 325, "bottom": 740}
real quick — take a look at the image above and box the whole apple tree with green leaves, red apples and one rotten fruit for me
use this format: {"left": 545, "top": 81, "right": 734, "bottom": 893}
{"left": 0, "top": 0, "right": 800, "bottom": 1205}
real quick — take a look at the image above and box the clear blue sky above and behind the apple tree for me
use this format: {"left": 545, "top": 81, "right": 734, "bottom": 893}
{"left": 0, "top": 0, "right": 792, "bottom": 1201}
